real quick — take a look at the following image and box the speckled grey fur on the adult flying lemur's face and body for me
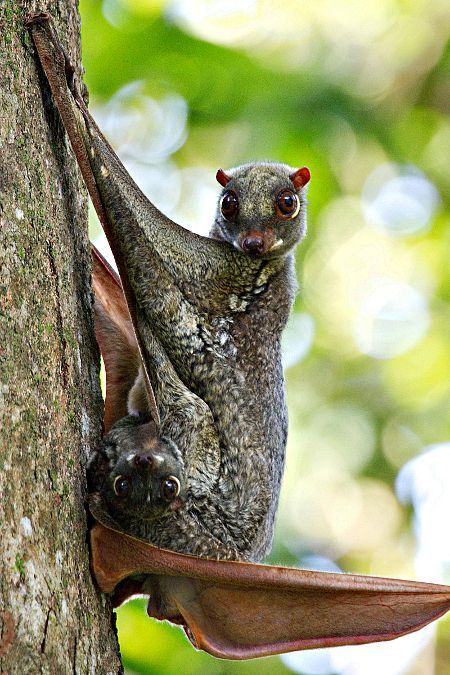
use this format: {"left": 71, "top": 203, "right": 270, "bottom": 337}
{"left": 78, "top": 108, "right": 305, "bottom": 560}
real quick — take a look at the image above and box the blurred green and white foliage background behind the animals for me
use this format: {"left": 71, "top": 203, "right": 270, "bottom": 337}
{"left": 80, "top": 0, "right": 450, "bottom": 675}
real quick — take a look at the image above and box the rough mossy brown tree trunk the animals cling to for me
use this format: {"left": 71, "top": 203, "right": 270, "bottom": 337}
{"left": 0, "top": 0, "right": 120, "bottom": 674}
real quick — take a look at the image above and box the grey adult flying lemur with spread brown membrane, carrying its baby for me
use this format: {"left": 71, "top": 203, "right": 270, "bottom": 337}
{"left": 28, "top": 14, "right": 450, "bottom": 659}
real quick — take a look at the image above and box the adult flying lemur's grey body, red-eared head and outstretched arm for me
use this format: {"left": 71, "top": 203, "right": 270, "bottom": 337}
{"left": 27, "top": 14, "right": 309, "bottom": 560}
